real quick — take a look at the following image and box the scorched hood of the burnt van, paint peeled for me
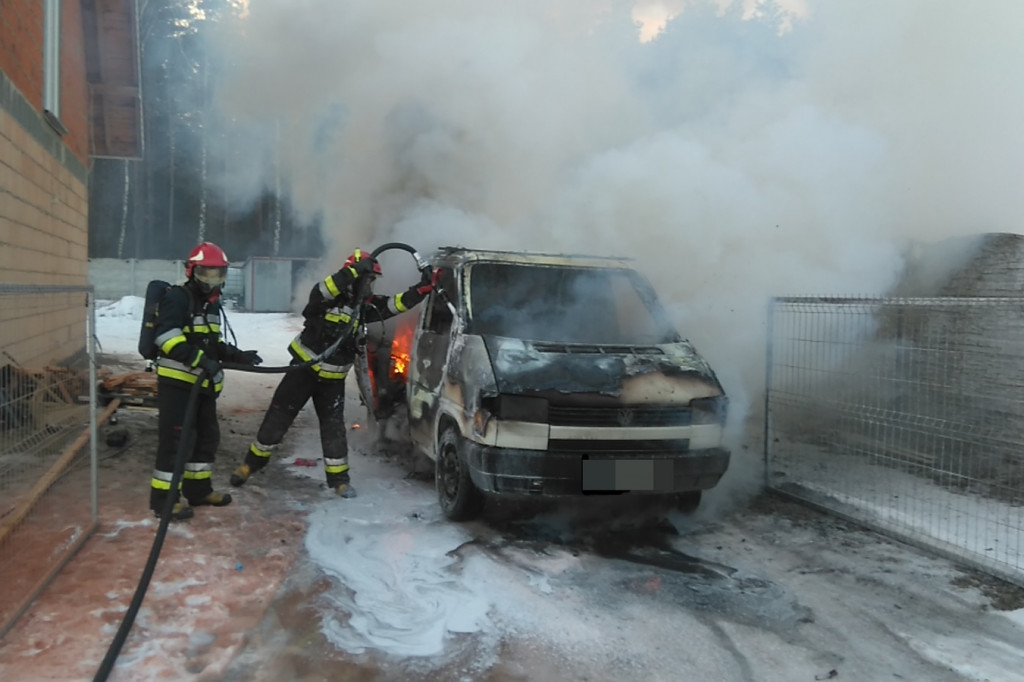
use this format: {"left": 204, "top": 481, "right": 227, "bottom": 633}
{"left": 482, "top": 336, "right": 722, "bottom": 401}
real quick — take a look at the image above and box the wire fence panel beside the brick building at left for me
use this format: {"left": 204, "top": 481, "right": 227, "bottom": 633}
{"left": 0, "top": 284, "right": 97, "bottom": 637}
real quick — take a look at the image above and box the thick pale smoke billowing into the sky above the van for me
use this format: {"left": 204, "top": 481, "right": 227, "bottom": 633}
{"left": 197, "top": 0, "right": 1024, "bottom": 446}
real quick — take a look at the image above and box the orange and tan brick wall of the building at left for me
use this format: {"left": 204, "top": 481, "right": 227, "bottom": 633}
{"left": 0, "top": 0, "right": 89, "bottom": 366}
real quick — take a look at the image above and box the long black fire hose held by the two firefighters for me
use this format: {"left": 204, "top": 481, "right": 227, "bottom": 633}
{"left": 93, "top": 242, "right": 432, "bottom": 682}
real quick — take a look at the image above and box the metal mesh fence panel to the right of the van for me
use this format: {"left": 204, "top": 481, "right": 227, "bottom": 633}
{"left": 765, "top": 298, "right": 1024, "bottom": 585}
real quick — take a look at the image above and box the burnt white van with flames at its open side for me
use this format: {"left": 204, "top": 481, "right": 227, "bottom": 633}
{"left": 357, "top": 248, "right": 729, "bottom": 520}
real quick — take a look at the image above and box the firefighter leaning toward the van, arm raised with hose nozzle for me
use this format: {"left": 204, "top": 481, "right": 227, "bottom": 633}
{"left": 231, "top": 249, "right": 433, "bottom": 498}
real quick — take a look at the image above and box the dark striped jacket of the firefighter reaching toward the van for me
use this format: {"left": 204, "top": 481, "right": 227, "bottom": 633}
{"left": 288, "top": 267, "right": 426, "bottom": 379}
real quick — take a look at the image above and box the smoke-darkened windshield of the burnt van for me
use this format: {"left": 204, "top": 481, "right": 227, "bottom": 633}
{"left": 467, "top": 263, "right": 679, "bottom": 345}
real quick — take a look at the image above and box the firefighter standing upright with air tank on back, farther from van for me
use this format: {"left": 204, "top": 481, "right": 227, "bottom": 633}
{"left": 150, "top": 242, "right": 262, "bottom": 520}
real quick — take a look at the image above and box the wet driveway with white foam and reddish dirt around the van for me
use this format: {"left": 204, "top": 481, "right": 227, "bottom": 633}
{"left": 0, "top": 358, "right": 1024, "bottom": 682}
